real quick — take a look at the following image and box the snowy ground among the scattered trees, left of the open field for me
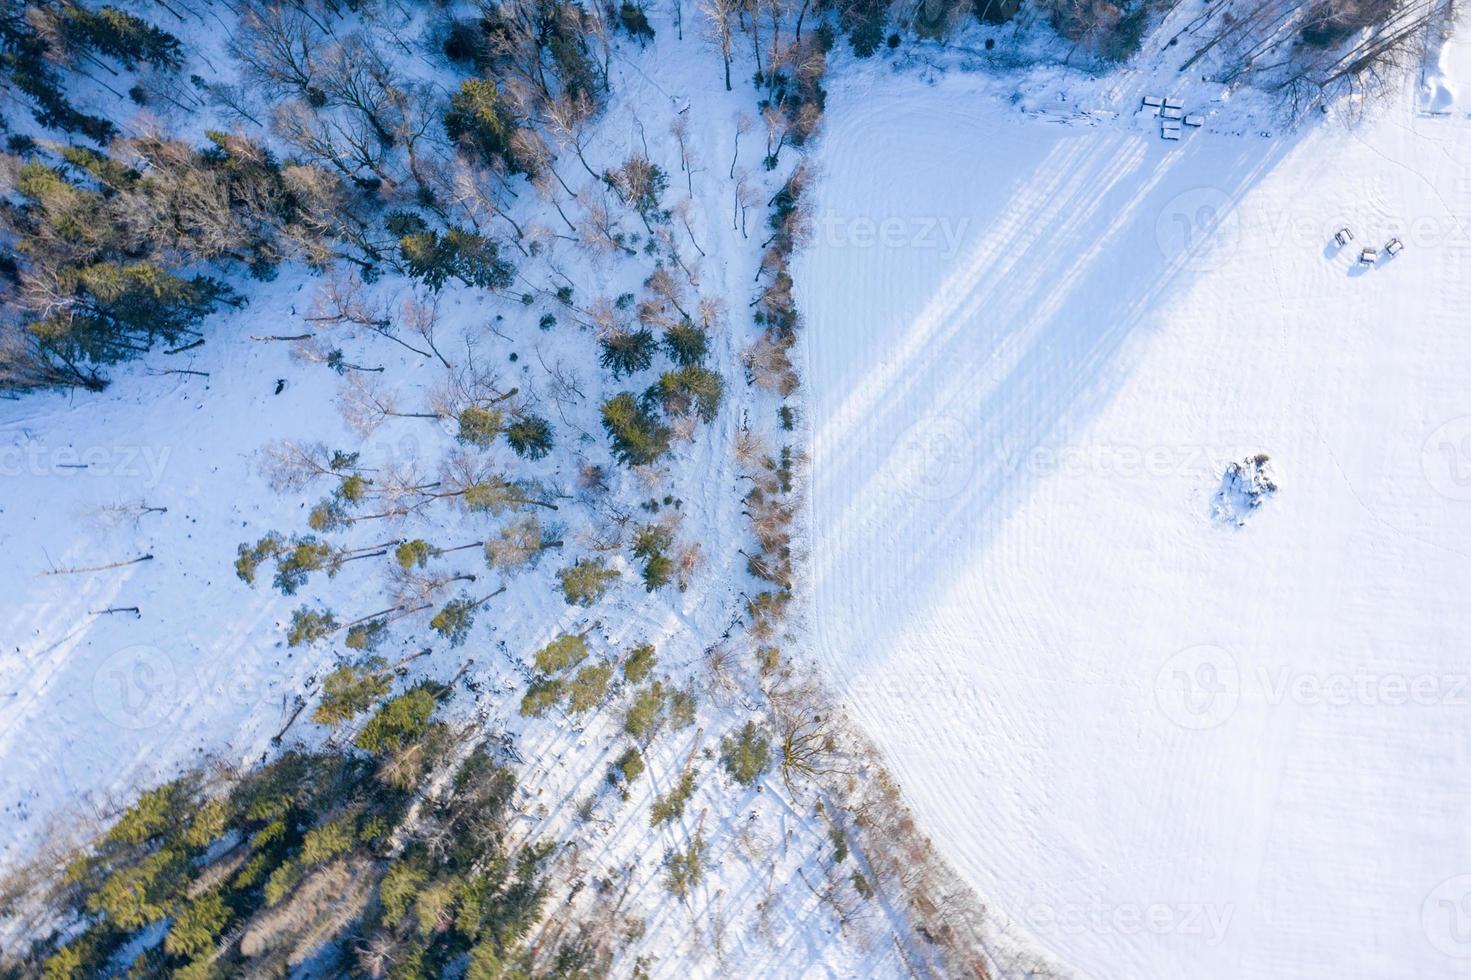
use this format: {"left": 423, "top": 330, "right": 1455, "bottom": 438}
{"left": 0, "top": 19, "right": 905, "bottom": 977}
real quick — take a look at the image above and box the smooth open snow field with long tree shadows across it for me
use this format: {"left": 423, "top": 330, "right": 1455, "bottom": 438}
{"left": 796, "top": 38, "right": 1471, "bottom": 977}
